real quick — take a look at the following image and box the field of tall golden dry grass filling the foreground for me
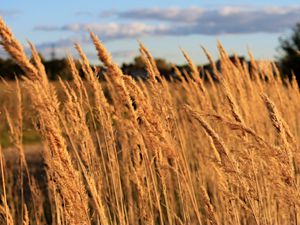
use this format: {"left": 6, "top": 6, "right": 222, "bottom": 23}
{"left": 0, "top": 16, "right": 300, "bottom": 225}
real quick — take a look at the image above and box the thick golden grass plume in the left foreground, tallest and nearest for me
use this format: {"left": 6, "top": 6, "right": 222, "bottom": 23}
{"left": 0, "top": 18, "right": 89, "bottom": 224}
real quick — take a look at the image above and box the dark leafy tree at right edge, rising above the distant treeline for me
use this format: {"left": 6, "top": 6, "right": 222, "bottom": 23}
{"left": 279, "top": 23, "right": 300, "bottom": 84}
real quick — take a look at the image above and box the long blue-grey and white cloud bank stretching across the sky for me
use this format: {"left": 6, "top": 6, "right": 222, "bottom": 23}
{"left": 34, "top": 6, "right": 300, "bottom": 59}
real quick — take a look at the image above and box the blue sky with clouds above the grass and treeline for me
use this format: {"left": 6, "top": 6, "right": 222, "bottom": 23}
{"left": 0, "top": 0, "right": 300, "bottom": 64}
